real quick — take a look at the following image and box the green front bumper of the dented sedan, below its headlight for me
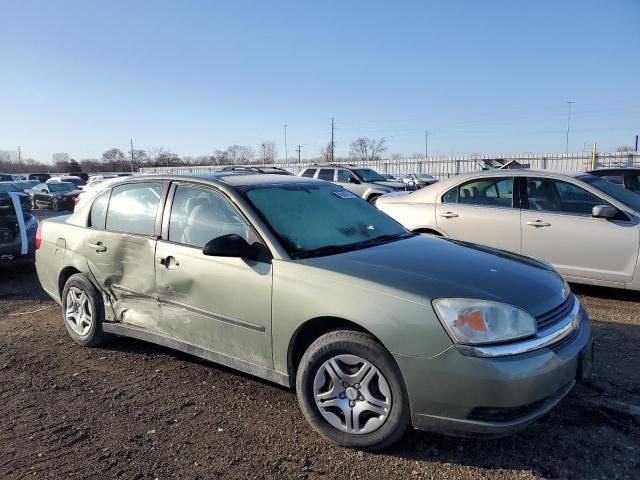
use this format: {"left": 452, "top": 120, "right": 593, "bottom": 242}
{"left": 394, "top": 308, "right": 592, "bottom": 436}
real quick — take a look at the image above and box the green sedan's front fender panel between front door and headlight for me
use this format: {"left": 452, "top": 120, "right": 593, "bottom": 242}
{"left": 272, "top": 260, "right": 452, "bottom": 372}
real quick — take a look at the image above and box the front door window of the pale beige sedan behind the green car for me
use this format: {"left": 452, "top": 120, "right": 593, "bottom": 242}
{"left": 527, "top": 178, "right": 606, "bottom": 215}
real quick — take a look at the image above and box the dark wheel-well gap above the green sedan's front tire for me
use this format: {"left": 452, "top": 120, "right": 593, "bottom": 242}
{"left": 287, "top": 317, "right": 386, "bottom": 388}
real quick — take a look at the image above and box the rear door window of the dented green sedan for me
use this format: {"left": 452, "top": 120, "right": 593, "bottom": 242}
{"left": 106, "top": 183, "right": 162, "bottom": 235}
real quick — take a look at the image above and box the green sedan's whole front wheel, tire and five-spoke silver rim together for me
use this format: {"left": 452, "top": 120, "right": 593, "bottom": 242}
{"left": 296, "top": 330, "right": 410, "bottom": 450}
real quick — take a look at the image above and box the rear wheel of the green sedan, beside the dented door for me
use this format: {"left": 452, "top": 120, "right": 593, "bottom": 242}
{"left": 62, "top": 273, "right": 110, "bottom": 347}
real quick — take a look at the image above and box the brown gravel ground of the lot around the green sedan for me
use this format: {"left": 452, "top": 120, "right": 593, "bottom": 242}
{"left": 0, "top": 212, "right": 640, "bottom": 479}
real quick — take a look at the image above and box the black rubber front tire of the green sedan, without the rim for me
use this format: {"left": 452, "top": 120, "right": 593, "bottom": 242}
{"left": 296, "top": 331, "right": 410, "bottom": 450}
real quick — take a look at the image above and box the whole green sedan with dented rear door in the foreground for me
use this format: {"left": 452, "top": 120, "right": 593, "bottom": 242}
{"left": 36, "top": 172, "right": 592, "bottom": 450}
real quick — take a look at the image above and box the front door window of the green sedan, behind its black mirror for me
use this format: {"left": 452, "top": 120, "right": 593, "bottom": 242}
{"left": 169, "top": 185, "right": 257, "bottom": 248}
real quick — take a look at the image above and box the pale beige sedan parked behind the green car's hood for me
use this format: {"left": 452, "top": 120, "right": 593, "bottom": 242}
{"left": 376, "top": 169, "right": 640, "bottom": 290}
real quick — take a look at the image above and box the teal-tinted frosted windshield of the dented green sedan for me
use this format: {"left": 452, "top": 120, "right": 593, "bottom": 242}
{"left": 246, "top": 184, "right": 413, "bottom": 258}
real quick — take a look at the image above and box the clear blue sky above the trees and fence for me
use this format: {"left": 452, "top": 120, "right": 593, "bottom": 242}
{"left": 0, "top": 0, "right": 640, "bottom": 161}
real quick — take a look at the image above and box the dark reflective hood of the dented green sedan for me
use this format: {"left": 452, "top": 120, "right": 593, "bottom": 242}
{"left": 304, "top": 235, "right": 566, "bottom": 316}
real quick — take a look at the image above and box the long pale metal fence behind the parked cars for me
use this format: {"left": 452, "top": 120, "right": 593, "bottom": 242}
{"left": 140, "top": 152, "right": 640, "bottom": 179}
